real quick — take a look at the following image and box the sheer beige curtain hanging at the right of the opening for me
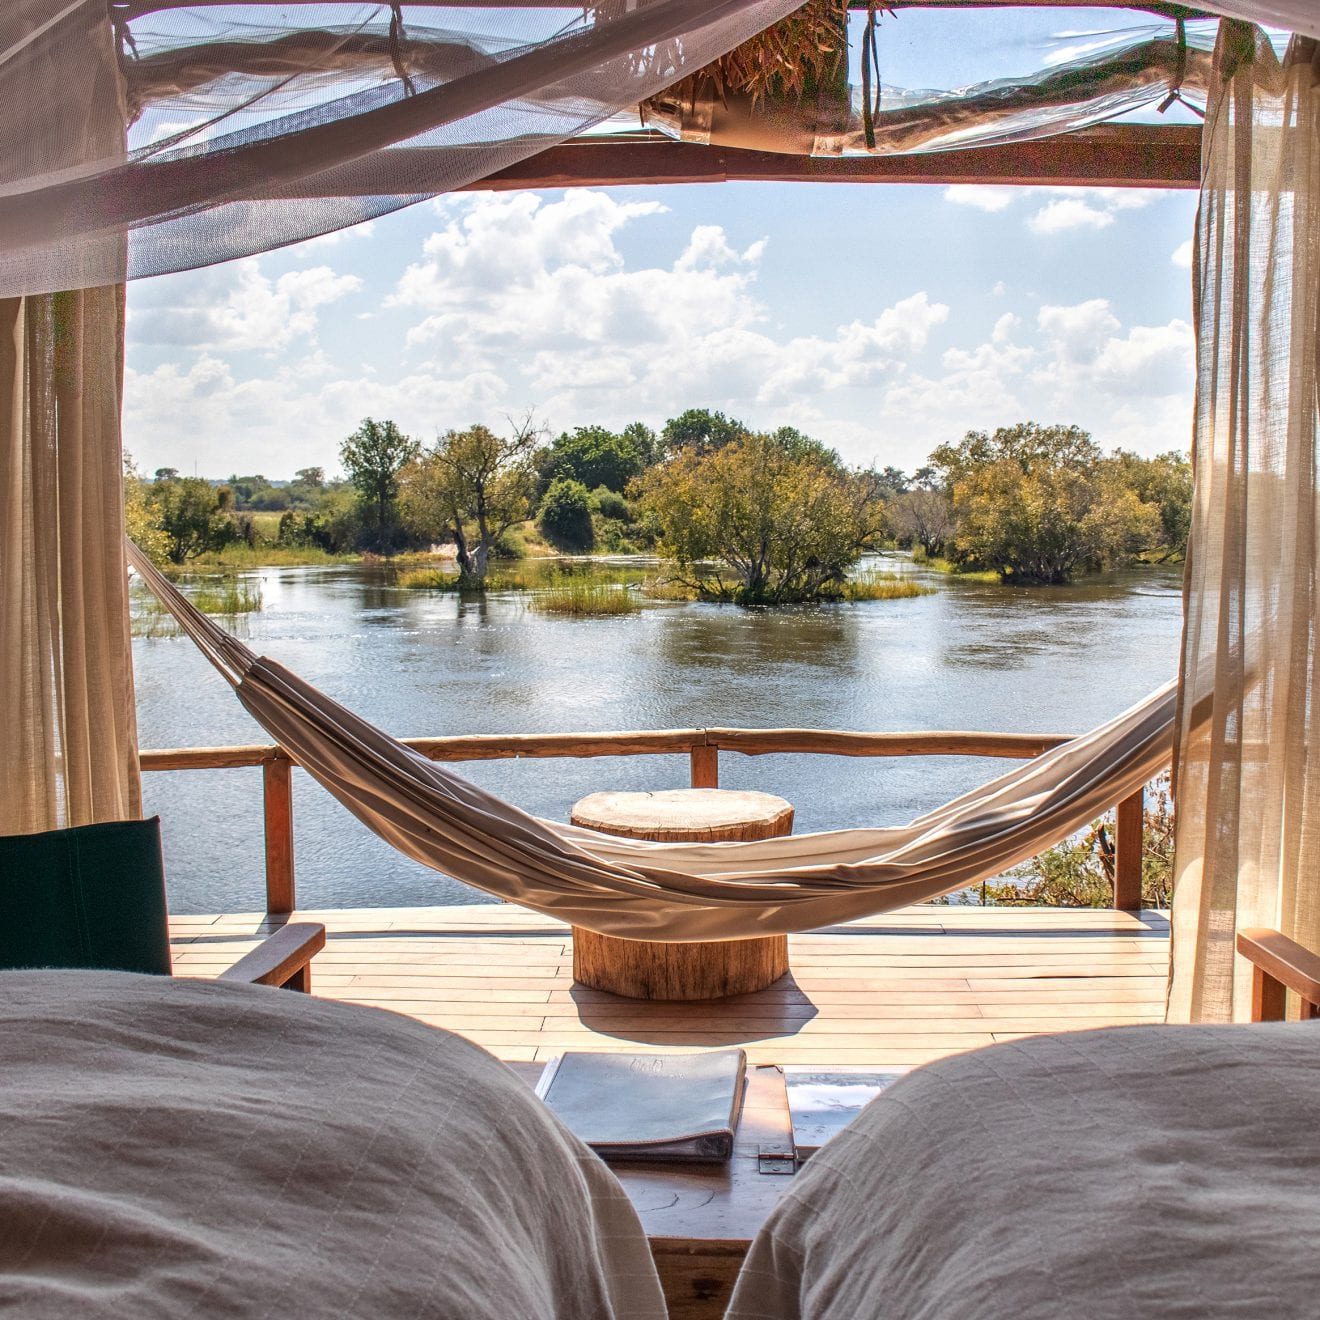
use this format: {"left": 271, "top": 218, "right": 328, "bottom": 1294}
{"left": 1170, "top": 24, "right": 1320, "bottom": 1022}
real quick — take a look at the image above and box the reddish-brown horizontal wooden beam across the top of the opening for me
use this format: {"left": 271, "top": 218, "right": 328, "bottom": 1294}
{"left": 464, "top": 124, "right": 1201, "bottom": 191}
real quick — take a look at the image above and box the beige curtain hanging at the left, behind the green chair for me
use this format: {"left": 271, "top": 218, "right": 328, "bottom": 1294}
{"left": 0, "top": 5, "right": 140, "bottom": 834}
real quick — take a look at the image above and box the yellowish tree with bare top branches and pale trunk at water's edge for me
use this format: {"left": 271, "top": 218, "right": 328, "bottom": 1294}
{"left": 401, "top": 417, "right": 540, "bottom": 587}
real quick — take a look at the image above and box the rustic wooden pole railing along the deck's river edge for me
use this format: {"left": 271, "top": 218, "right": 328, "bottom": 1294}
{"left": 140, "top": 729, "right": 1144, "bottom": 913}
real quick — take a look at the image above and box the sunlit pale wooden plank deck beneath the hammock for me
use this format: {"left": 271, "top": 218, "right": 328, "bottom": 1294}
{"left": 170, "top": 904, "right": 1168, "bottom": 1065}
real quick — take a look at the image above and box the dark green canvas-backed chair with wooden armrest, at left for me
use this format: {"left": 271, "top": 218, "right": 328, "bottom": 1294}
{"left": 0, "top": 816, "right": 325, "bottom": 990}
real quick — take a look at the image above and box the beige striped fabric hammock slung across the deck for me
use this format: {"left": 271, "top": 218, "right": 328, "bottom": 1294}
{"left": 128, "top": 545, "right": 1176, "bottom": 942}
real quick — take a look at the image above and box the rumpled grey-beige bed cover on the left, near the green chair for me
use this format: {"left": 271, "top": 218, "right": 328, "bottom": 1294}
{"left": 0, "top": 972, "right": 664, "bottom": 1320}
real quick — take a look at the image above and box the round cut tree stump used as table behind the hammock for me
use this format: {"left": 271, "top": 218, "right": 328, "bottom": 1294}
{"left": 569, "top": 788, "right": 793, "bottom": 999}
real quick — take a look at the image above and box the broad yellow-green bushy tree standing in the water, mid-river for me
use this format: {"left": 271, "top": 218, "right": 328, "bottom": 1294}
{"left": 642, "top": 434, "right": 884, "bottom": 605}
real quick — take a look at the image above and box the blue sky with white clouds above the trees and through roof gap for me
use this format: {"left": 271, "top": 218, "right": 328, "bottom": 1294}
{"left": 125, "top": 11, "right": 1196, "bottom": 478}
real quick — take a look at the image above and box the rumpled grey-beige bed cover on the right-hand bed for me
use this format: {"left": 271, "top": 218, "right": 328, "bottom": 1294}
{"left": 726, "top": 1023, "right": 1320, "bottom": 1320}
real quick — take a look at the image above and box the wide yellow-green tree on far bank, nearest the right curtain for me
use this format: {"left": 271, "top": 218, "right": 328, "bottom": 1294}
{"left": 931, "top": 422, "right": 1159, "bottom": 583}
